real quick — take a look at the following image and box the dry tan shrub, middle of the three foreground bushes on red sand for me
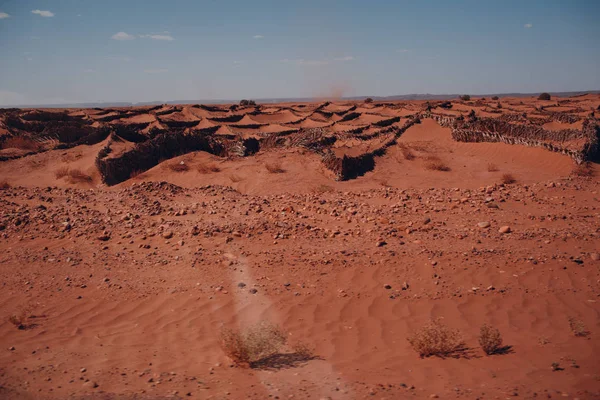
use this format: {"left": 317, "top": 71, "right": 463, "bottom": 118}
{"left": 408, "top": 319, "right": 466, "bottom": 358}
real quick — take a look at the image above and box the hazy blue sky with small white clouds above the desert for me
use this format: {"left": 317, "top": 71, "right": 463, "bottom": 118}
{"left": 0, "top": 0, "right": 600, "bottom": 105}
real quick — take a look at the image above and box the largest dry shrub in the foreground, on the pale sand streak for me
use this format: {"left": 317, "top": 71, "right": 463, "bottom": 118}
{"left": 221, "top": 322, "right": 287, "bottom": 367}
